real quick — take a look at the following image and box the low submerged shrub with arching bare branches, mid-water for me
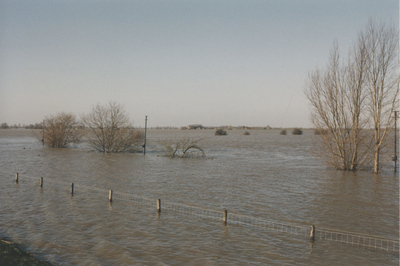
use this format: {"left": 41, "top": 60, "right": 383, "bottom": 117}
{"left": 161, "top": 138, "right": 205, "bottom": 158}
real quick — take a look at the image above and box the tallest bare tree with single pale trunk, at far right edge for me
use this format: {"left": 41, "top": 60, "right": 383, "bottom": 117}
{"left": 359, "top": 20, "right": 399, "bottom": 173}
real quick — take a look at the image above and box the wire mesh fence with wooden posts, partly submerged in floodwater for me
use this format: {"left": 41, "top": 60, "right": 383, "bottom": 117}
{"left": 10, "top": 173, "right": 400, "bottom": 252}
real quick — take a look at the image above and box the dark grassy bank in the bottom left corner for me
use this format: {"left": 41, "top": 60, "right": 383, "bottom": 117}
{"left": 0, "top": 238, "right": 51, "bottom": 266}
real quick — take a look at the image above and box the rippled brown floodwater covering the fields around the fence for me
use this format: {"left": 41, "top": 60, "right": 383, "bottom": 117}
{"left": 0, "top": 130, "right": 399, "bottom": 265}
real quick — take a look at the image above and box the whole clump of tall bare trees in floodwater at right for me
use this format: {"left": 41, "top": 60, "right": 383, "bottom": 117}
{"left": 305, "top": 21, "right": 399, "bottom": 172}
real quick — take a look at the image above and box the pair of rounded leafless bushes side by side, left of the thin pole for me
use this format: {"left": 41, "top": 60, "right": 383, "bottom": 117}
{"left": 38, "top": 102, "right": 143, "bottom": 153}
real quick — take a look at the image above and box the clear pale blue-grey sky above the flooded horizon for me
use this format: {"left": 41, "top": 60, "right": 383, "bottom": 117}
{"left": 0, "top": 0, "right": 399, "bottom": 127}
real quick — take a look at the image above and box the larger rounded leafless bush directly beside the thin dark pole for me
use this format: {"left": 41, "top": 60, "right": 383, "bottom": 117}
{"left": 81, "top": 102, "right": 143, "bottom": 153}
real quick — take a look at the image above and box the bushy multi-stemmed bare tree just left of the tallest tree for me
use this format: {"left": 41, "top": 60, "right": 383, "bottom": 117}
{"left": 305, "top": 42, "right": 369, "bottom": 171}
